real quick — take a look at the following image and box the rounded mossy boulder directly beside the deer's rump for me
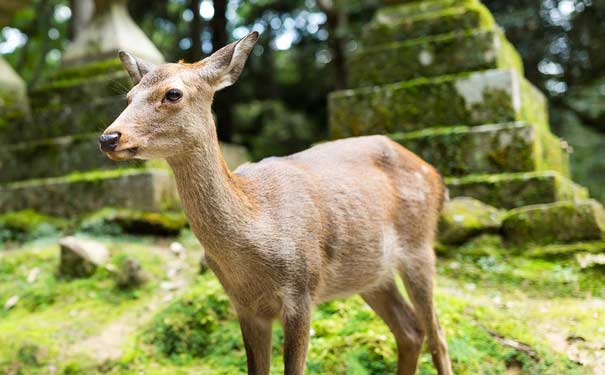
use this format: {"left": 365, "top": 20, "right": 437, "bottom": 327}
{"left": 438, "top": 197, "right": 503, "bottom": 244}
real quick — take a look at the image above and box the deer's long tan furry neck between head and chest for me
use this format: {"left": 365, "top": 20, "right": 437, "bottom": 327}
{"left": 168, "top": 122, "right": 253, "bottom": 257}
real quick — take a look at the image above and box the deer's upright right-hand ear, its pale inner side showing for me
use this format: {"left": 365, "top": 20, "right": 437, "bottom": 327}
{"left": 201, "top": 31, "right": 258, "bottom": 91}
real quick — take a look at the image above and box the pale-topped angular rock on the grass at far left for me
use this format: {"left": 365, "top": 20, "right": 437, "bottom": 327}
{"left": 59, "top": 236, "right": 109, "bottom": 277}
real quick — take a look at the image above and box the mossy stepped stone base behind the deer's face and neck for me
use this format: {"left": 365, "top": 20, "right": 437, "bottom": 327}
{"left": 0, "top": 59, "right": 247, "bottom": 216}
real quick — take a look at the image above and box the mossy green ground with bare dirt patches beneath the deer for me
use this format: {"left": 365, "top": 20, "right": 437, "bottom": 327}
{"left": 0, "top": 231, "right": 605, "bottom": 375}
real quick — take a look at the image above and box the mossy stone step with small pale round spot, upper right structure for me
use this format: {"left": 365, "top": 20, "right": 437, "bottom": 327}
{"left": 349, "top": 29, "right": 523, "bottom": 87}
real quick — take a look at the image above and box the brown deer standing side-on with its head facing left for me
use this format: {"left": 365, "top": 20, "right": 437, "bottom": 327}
{"left": 99, "top": 33, "right": 452, "bottom": 375}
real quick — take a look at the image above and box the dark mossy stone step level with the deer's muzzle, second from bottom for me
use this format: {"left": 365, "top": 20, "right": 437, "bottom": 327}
{"left": 0, "top": 132, "right": 249, "bottom": 182}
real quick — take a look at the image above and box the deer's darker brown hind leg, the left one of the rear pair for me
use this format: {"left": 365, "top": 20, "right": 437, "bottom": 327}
{"left": 361, "top": 280, "right": 424, "bottom": 375}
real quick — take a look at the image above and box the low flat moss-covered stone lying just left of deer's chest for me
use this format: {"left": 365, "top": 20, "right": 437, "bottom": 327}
{"left": 80, "top": 208, "right": 187, "bottom": 236}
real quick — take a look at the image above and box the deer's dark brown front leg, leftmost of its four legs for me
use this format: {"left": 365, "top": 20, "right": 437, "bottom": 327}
{"left": 239, "top": 314, "right": 271, "bottom": 375}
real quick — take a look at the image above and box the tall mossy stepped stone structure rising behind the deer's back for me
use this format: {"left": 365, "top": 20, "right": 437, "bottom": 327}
{"left": 328, "top": 0, "right": 602, "bottom": 242}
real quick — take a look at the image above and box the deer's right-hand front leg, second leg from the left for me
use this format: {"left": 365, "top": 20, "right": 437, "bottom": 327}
{"left": 282, "top": 302, "right": 311, "bottom": 375}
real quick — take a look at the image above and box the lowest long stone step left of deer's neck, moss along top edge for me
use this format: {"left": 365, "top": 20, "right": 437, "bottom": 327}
{"left": 0, "top": 169, "right": 179, "bottom": 216}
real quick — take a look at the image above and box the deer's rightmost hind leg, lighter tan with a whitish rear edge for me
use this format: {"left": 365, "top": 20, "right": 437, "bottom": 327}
{"left": 401, "top": 246, "right": 453, "bottom": 375}
